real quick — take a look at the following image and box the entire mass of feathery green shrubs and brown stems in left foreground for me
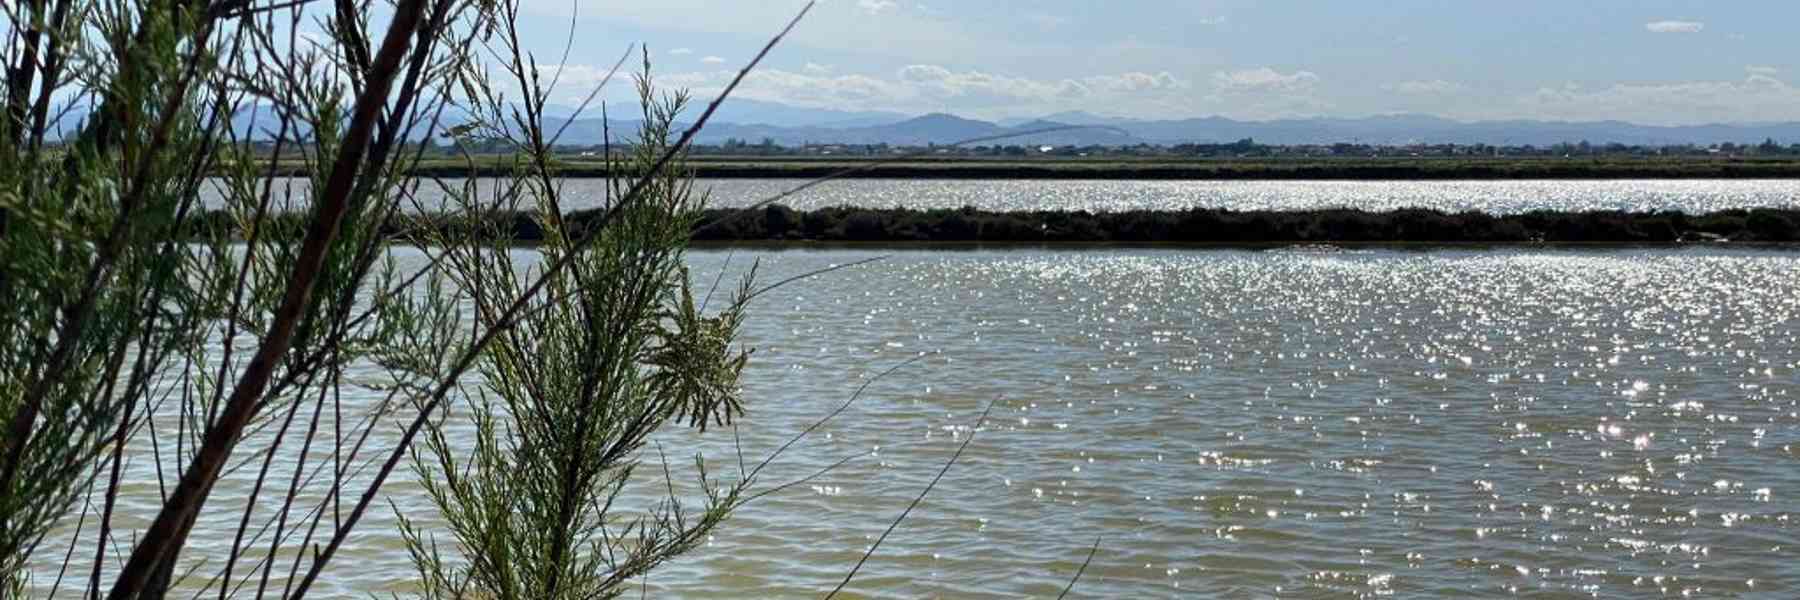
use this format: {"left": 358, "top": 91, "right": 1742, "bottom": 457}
{"left": 0, "top": 0, "right": 788, "bottom": 587}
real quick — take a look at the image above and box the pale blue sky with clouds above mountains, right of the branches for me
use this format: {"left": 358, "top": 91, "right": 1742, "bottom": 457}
{"left": 522, "top": 0, "right": 1800, "bottom": 124}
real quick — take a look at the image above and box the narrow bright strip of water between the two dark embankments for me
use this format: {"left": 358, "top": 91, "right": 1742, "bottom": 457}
{"left": 205, "top": 178, "right": 1800, "bottom": 214}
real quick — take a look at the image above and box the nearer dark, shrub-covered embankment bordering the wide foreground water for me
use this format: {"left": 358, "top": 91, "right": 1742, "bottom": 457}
{"left": 189, "top": 205, "right": 1800, "bottom": 245}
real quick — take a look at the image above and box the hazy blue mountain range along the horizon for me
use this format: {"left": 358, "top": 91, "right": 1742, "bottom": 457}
{"left": 49, "top": 99, "right": 1800, "bottom": 146}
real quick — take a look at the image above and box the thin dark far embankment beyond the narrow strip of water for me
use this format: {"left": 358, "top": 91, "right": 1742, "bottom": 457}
{"left": 262, "top": 157, "right": 1800, "bottom": 180}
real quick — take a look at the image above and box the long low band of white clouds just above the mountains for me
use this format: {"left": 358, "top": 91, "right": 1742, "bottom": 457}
{"left": 545, "top": 65, "right": 1800, "bottom": 124}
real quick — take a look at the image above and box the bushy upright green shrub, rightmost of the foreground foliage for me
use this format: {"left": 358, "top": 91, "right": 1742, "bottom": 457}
{"left": 394, "top": 47, "right": 751, "bottom": 598}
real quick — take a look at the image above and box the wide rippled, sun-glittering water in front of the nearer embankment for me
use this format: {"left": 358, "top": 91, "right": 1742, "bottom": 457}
{"left": 28, "top": 249, "right": 1800, "bottom": 598}
